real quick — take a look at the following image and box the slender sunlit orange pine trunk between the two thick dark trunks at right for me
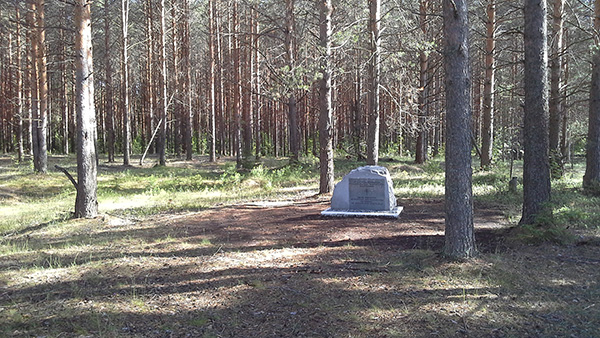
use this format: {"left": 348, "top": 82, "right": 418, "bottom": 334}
{"left": 481, "top": 0, "right": 496, "bottom": 168}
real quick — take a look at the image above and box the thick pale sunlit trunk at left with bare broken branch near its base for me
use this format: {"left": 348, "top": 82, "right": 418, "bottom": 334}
{"left": 75, "top": 0, "right": 98, "bottom": 218}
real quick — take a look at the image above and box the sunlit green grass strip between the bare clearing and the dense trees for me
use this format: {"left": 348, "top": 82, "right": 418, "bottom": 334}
{"left": 0, "top": 156, "right": 600, "bottom": 234}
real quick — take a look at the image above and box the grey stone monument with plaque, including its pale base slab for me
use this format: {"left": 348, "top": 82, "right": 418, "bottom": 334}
{"left": 321, "top": 166, "right": 403, "bottom": 218}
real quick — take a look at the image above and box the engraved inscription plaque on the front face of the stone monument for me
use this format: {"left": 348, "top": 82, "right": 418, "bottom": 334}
{"left": 348, "top": 178, "right": 390, "bottom": 211}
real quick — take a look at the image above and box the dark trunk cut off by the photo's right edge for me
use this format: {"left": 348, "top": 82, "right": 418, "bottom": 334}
{"left": 583, "top": 0, "right": 600, "bottom": 191}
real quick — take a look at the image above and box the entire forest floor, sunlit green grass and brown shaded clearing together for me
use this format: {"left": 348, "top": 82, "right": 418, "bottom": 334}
{"left": 0, "top": 156, "right": 600, "bottom": 337}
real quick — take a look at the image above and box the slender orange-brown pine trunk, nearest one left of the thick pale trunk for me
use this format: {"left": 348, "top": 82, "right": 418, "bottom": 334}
{"left": 36, "top": 0, "right": 48, "bottom": 174}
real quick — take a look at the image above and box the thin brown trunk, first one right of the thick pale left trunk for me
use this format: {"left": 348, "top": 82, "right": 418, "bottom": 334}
{"left": 104, "top": 0, "right": 115, "bottom": 163}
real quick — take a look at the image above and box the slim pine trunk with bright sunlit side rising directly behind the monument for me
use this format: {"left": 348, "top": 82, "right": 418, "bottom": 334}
{"left": 367, "top": 0, "right": 381, "bottom": 165}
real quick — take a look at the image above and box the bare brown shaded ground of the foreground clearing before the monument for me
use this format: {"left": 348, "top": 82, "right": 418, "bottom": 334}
{"left": 0, "top": 199, "right": 600, "bottom": 337}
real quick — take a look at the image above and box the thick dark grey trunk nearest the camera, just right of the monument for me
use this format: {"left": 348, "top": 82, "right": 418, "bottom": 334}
{"left": 443, "top": 0, "right": 477, "bottom": 258}
